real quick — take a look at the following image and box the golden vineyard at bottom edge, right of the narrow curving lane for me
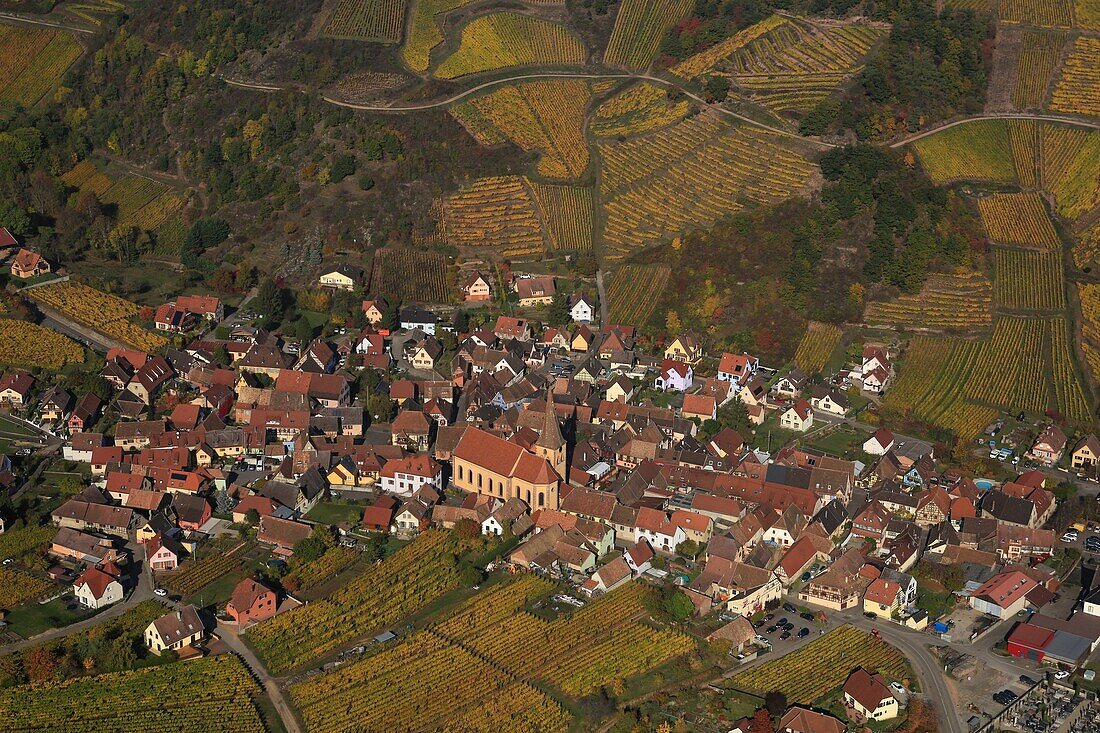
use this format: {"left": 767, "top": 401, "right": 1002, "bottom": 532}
{"left": 290, "top": 632, "right": 570, "bottom": 733}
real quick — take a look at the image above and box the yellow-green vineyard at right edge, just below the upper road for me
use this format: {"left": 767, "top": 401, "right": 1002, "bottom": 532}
{"left": 1041, "top": 124, "right": 1100, "bottom": 219}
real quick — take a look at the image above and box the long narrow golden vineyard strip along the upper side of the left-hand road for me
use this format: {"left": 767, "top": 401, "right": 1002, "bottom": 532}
{"left": 28, "top": 281, "right": 167, "bottom": 351}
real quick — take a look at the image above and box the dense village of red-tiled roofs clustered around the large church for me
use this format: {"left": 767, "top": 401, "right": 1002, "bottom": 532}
{"left": 0, "top": 250, "right": 1100, "bottom": 733}
